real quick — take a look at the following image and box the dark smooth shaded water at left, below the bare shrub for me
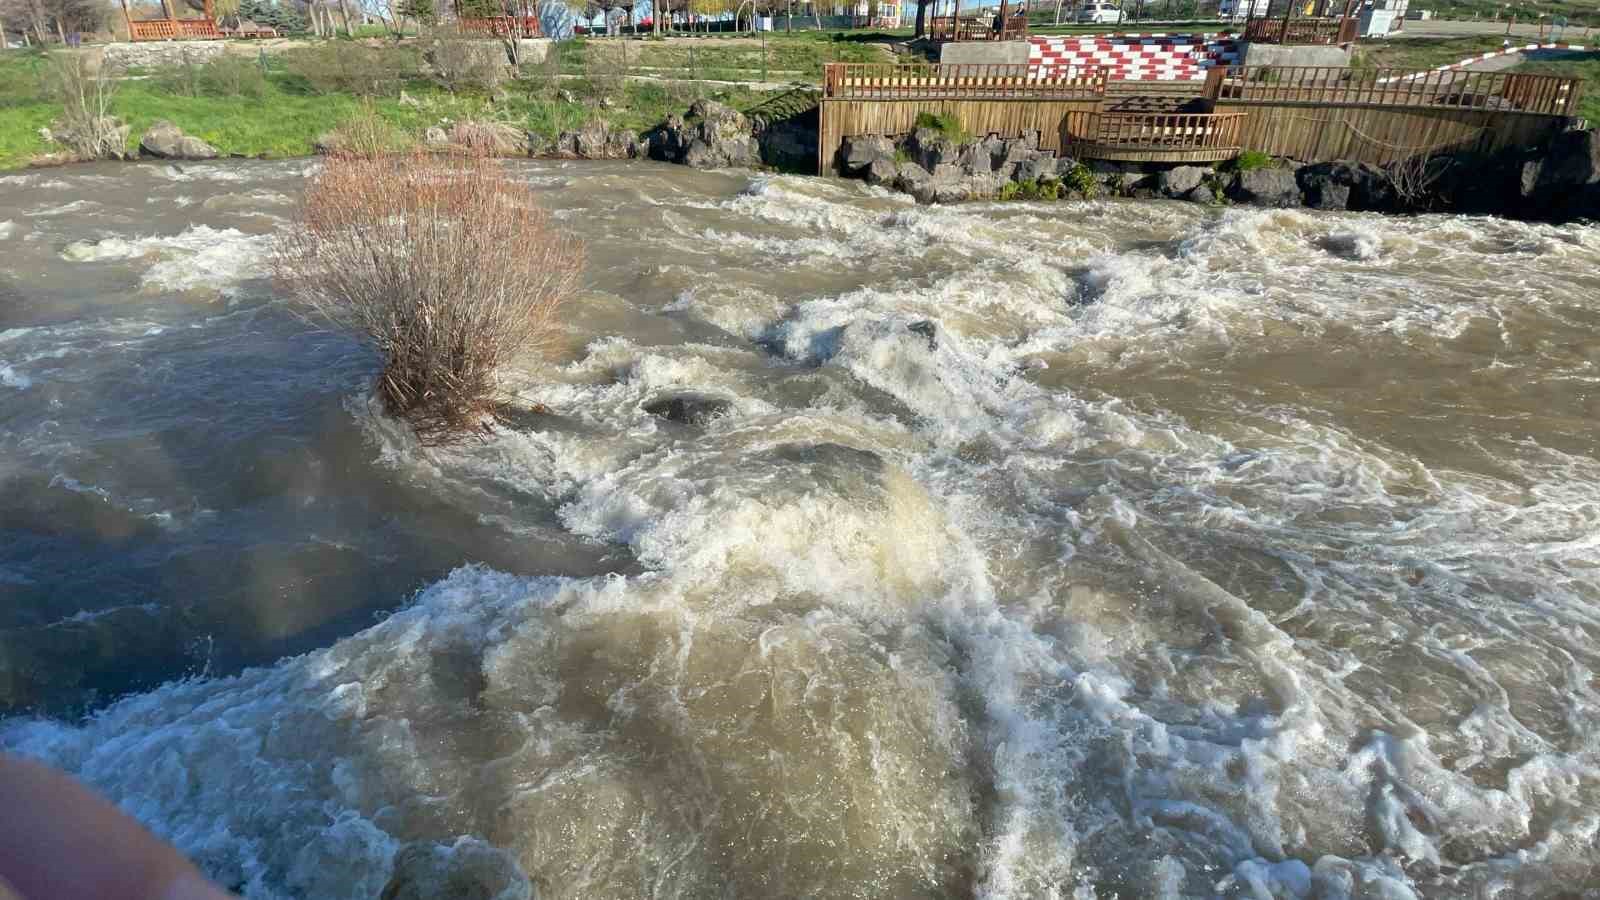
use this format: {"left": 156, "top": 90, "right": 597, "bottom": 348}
{"left": 0, "top": 294, "right": 630, "bottom": 714}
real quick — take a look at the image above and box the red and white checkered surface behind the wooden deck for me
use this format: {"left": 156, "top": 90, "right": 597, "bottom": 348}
{"left": 1027, "top": 34, "right": 1238, "bottom": 82}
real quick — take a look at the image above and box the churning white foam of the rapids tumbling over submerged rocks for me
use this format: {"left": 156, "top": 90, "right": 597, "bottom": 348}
{"left": 0, "top": 164, "right": 1600, "bottom": 898}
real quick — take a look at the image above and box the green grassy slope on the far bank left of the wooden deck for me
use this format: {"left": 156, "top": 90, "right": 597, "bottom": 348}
{"left": 0, "top": 38, "right": 826, "bottom": 168}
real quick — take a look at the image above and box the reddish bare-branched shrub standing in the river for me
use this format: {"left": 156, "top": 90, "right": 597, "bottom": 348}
{"left": 275, "top": 154, "right": 582, "bottom": 444}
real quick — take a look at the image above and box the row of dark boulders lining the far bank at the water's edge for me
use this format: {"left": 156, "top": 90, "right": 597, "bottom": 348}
{"left": 28, "top": 99, "right": 1600, "bottom": 223}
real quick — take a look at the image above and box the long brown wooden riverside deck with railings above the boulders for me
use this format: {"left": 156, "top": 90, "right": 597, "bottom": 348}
{"left": 818, "top": 64, "right": 1582, "bottom": 171}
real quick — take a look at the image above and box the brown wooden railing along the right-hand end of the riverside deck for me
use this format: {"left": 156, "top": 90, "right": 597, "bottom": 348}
{"left": 1213, "top": 66, "right": 1582, "bottom": 115}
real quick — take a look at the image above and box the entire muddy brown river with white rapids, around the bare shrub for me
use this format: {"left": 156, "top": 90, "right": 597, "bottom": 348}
{"left": 0, "top": 162, "right": 1600, "bottom": 900}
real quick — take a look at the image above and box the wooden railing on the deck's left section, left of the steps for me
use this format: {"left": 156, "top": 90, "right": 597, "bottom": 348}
{"left": 822, "top": 62, "right": 1106, "bottom": 99}
